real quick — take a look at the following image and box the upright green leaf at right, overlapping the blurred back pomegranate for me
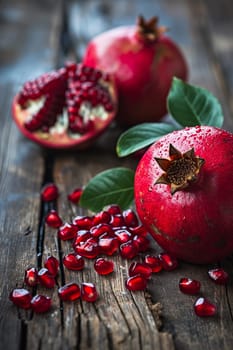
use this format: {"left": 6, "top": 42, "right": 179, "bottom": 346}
{"left": 167, "top": 78, "right": 223, "bottom": 127}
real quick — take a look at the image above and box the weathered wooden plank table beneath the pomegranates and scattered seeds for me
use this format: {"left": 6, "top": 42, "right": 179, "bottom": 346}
{"left": 0, "top": 0, "right": 233, "bottom": 350}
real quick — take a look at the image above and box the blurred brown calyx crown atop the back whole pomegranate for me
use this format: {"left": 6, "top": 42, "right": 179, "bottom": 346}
{"left": 137, "top": 15, "right": 168, "bottom": 42}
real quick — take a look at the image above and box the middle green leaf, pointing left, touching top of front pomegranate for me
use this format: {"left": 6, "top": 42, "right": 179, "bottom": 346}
{"left": 116, "top": 123, "right": 177, "bottom": 157}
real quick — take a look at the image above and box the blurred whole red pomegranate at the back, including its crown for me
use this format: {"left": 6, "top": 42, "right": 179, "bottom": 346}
{"left": 83, "top": 17, "right": 187, "bottom": 126}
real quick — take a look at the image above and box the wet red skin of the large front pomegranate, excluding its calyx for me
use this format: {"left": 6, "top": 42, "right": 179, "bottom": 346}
{"left": 134, "top": 126, "right": 233, "bottom": 264}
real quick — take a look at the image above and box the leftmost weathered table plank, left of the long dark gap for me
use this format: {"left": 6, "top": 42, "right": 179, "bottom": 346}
{"left": 0, "top": 1, "right": 63, "bottom": 349}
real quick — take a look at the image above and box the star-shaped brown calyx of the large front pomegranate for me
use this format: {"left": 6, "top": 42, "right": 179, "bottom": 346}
{"left": 155, "top": 144, "right": 205, "bottom": 195}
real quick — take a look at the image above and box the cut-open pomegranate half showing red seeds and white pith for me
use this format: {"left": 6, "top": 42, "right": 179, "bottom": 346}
{"left": 13, "top": 63, "right": 117, "bottom": 149}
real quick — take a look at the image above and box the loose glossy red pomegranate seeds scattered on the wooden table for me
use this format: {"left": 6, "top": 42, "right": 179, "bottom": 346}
{"left": 9, "top": 197, "right": 228, "bottom": 317}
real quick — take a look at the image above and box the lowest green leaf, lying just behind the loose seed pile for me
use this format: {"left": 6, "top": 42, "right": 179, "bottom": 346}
{"left": 80, "top": 167, "right": 134, "bottom": 212}
